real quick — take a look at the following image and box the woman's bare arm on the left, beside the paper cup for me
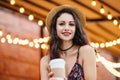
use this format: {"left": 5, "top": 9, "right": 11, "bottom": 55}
{"left": 40, "top": 56, "right": 48, "bottom": 80}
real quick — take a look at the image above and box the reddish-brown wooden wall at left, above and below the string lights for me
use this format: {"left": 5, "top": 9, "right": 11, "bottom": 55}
{"left": 0, "top": 9, "right": 41, "bottom": 80}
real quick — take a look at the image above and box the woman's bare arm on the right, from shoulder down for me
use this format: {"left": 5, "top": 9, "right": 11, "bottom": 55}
{"left": 82, "top": 45, "right": 96, "bottom": 80}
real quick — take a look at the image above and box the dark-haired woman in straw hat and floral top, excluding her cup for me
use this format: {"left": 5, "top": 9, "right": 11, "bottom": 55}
{"left": 40, "top": 5, "right": 96, "bottom": 80}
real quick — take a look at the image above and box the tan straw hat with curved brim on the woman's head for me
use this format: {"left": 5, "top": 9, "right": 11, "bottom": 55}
{"left": 46, "top": 5, "right": 86, "bottom": 31}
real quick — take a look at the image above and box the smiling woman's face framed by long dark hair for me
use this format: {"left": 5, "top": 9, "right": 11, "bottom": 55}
{"left": 56, "top": 13, "right": 76, "bottom": 41}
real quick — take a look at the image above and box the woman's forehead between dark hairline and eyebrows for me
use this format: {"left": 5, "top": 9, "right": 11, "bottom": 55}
{"left": 57, "top": 13, "right": 74, "bottom": 21}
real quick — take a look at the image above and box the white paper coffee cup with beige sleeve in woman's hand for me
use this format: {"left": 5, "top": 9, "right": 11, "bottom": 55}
{"left": 49, "top": 58, "right": 65, "bottom": 80}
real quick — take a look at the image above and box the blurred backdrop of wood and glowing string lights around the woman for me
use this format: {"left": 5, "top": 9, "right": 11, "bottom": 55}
{"left": 0, "top": 0, "right": 120, "bottom": 80}
